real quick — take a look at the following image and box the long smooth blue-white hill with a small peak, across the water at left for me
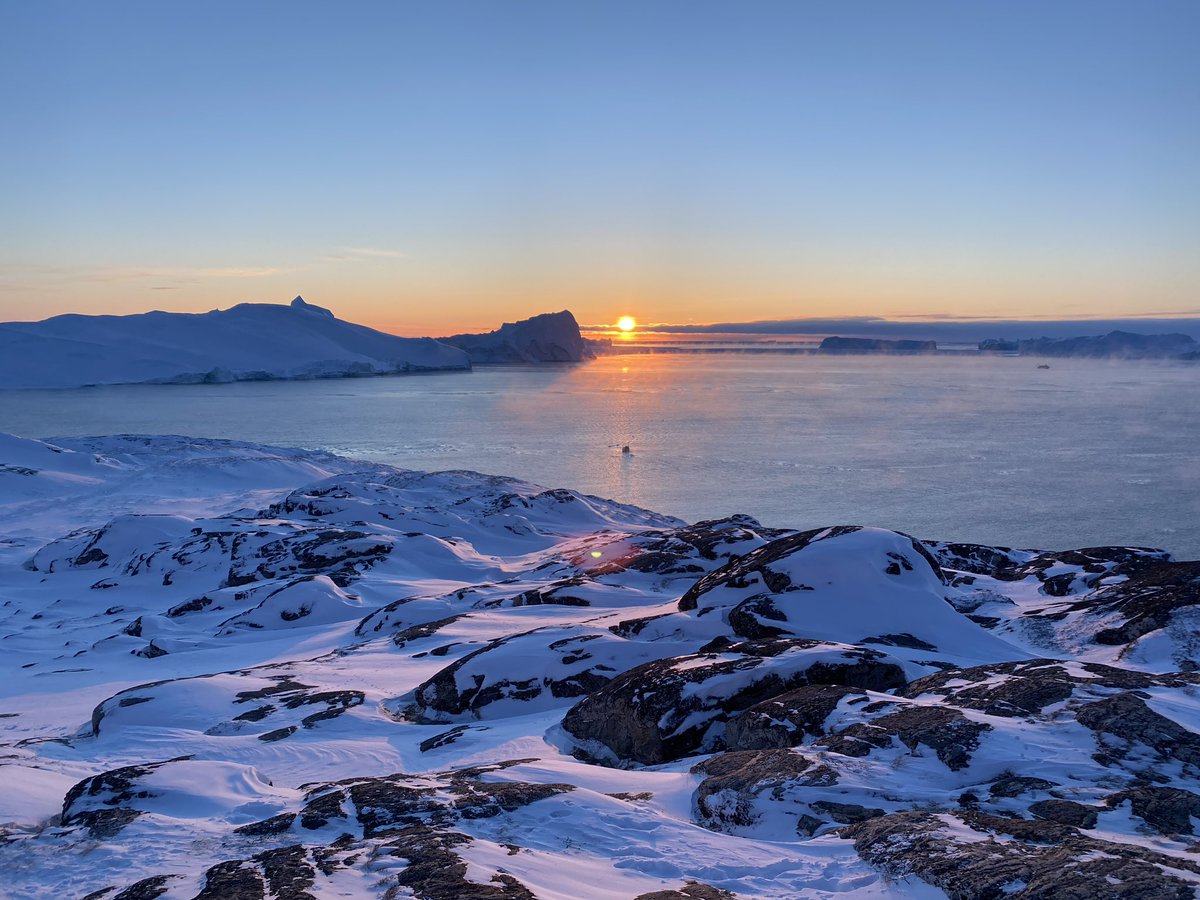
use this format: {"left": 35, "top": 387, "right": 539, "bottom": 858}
{"left": 0, "top": 296, "right": 470, "bottom": 388}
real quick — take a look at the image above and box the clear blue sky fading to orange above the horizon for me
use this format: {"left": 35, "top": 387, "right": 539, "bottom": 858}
{"left": 0, "top": 0, "right": 1200, "bottom": 335}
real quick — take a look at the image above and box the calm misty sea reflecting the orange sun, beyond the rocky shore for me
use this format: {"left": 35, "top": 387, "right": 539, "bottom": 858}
{"left": 0, "top": 354, "right": 1200, "bottom": 558}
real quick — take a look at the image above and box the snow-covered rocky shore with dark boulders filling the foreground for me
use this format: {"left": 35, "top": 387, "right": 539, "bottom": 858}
{"left": 0, "top": 436, "right": 1200, "bottom": 900}
